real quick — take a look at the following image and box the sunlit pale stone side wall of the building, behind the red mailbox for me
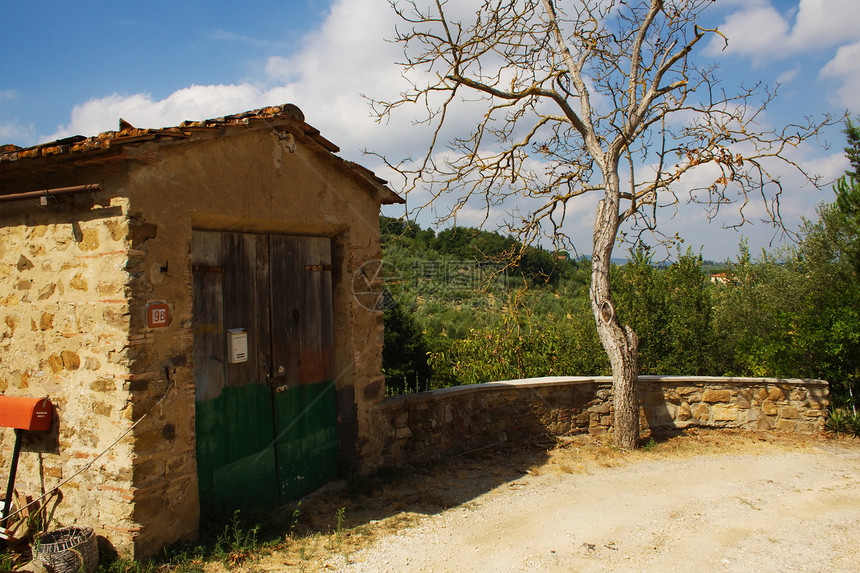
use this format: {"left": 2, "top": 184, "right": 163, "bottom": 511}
{"left": 0, "top": 199, "right": 133, "bottom": 535}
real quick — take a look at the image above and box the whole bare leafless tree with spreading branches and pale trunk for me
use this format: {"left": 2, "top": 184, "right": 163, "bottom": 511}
{"left": 372, "top": 0, "right": 830, "bottom": 448}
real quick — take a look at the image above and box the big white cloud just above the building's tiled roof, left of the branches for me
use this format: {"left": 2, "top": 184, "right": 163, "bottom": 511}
{"left": 50, "top": 0, "right": 415, "bottom": 159}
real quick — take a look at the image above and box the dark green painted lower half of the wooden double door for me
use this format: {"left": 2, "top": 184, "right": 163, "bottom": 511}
{"left": 196, "top": 381, "right": 338, "bottom": 508}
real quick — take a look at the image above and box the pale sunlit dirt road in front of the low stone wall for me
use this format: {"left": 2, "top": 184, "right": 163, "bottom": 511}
{"left": 336, "top": 439, "right": 860, "bottom": 573}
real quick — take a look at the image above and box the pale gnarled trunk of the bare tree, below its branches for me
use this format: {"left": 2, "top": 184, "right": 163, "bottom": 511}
{"left": 590, "top": 185, "right": 639, "bottom": 449}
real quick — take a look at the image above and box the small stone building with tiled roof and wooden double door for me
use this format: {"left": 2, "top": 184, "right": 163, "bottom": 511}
{"left": 0, "top": 104, "right": 402, "bottom": 556}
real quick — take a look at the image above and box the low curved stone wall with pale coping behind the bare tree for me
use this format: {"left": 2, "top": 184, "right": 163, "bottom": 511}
{"left": 376, "top": 376, "right": 828, "bottom": 466}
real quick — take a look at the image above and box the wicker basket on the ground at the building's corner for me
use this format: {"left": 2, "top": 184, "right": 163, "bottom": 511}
{"left": 36, "top": 525, "right": 99, "bottom": 573}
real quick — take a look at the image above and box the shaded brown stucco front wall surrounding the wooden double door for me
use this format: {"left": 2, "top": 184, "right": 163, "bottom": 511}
{"left": 119, "top": 125, "right": 383, "bottom": 554}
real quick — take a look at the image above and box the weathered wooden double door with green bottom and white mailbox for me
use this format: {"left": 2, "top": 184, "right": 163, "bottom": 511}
{"left": 192, "top": 231, "right": 338, "bottom": 507}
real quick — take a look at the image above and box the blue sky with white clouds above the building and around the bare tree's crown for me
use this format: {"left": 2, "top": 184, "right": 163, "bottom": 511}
{"left": 0, "top": 0, "right": 860, "bottom": 260}
